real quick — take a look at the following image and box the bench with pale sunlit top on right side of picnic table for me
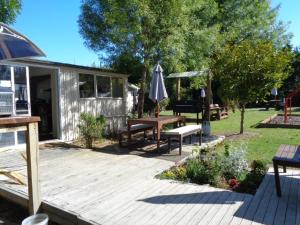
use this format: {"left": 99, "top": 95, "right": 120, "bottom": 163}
{"left": 161, "top": 125, "right": 202, "bottom": 155}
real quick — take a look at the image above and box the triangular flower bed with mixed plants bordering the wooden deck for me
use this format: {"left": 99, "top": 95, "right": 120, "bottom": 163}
{"left": 158, "top": 145, "right": 267, "bottom": 194}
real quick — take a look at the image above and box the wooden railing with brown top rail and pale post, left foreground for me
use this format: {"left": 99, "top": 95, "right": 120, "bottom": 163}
{"left": 0, "top": 116, "right": 41, "bottom": 214}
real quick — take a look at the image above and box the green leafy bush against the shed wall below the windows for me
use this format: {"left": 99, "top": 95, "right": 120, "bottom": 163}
{"left": 78, "top": 113, "right": 106, "bottom": 148}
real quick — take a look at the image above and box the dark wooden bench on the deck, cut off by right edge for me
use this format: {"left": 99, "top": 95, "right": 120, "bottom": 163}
{"left": 273, "top": 145, "right": 300, "bottom": 197}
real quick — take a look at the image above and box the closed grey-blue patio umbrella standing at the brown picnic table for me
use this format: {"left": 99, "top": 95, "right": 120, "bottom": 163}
{"left": 149, "top": 64, "right": 168, "bottom": 117}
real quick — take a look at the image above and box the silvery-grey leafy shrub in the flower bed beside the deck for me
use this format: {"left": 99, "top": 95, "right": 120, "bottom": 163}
{"left": 220, "top": 144, "right": 248, "bottom": 180}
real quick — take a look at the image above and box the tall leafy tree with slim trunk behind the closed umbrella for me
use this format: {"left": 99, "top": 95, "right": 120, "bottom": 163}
{"left": 78, "top": 0, "right": 193, "bottom": 117}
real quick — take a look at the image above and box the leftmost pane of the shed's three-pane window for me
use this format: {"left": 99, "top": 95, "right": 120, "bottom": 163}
{"left": 79, "top": 74, "right": 95, "bottom": 98}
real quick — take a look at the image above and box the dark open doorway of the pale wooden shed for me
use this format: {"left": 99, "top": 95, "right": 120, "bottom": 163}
{"left": 29, "top": 67, "right": 58, "bottom": 141}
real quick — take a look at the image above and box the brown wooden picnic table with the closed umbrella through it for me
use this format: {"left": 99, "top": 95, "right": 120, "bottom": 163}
{"left": 127, "top": 116, "right": 185, "bottom": 150}
